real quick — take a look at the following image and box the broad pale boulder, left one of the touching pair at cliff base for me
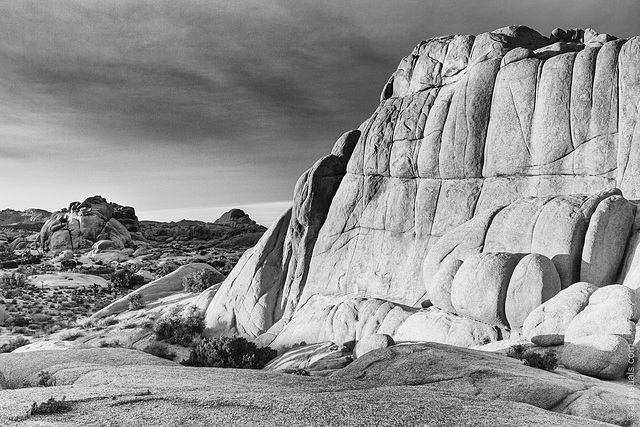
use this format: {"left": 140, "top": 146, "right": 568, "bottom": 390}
{"left": 451, "top": 252, "right": 524, "bottom": 328}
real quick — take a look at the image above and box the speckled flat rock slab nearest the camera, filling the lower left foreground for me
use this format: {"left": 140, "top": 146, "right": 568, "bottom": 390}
{"left": 0, "top": 349, "right": 606, "bottom": 427}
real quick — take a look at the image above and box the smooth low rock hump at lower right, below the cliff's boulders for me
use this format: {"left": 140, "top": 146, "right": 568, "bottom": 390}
{"left": 331, "top": 343, "right": 640, "bottom": 425}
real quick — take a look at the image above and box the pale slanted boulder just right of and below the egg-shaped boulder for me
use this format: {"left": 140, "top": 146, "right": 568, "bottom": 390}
{"left": 522, "top": 282, "right": 598, "bottom": 347}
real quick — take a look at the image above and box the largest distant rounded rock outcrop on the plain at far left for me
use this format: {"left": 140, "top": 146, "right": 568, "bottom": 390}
{"left": 40, "top": 196, "right": 138, "bottom": 251}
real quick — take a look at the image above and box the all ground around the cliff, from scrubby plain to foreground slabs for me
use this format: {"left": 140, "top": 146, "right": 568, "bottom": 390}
{"left": 0, "top": 201, "right": 640, "bottom": 426}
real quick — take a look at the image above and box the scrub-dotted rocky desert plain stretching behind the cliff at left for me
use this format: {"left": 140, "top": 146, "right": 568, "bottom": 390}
{"left": 0, "top": 205, "right": 265, "bottom": 350}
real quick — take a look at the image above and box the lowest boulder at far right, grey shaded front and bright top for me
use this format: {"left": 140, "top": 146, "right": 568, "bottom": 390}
{"left": 561, "top": 334, "right": 630, "bottom": 380}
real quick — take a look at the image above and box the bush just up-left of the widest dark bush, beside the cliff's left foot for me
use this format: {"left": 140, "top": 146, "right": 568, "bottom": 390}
{"left": 153, "top": 306, "right": 204, "bottom": 347}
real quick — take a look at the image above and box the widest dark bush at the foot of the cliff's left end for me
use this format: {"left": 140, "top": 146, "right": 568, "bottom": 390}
{"left": 181, "top": 337, "right": 278, "bottom": 369}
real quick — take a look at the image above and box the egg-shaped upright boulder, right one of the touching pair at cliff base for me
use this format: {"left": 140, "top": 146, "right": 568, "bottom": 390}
{"left": 504, "top": 254, "right": 561, "bottom": 329}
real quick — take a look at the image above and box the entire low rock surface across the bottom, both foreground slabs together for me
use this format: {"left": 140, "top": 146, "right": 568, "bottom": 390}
{"left": 0, "top": 345, "right": 637, "bottom": 427}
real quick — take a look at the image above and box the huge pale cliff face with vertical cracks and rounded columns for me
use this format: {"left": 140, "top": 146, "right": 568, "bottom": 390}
{"left": 200, "top": 26, "right": 640, "bottom": 362}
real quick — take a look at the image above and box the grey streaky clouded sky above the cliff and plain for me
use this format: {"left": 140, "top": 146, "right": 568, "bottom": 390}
{"left": 0, "top": 0, "right": 640, "bottom": 225}
